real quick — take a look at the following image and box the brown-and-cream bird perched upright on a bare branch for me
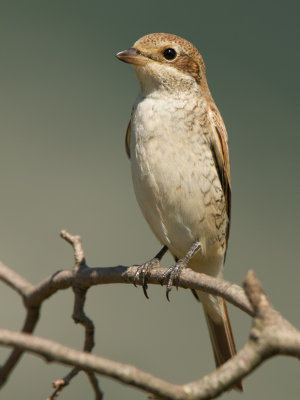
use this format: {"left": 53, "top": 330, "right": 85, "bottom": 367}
{"left": 116, "top": 33, "right": 243, "bottom": 391}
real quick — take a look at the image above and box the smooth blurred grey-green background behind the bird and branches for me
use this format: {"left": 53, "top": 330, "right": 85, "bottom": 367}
{"left": 0, "top": 0, "right": 300, "bottom": 400}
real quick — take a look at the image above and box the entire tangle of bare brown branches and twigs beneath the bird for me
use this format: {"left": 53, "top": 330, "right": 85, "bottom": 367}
{"left": 0, "top": 231, "right": 300, "bottom": 400}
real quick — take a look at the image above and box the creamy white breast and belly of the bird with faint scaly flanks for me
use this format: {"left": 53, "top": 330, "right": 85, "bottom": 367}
{"left": 131, "top": 92, "right": 225, "bottom": 276}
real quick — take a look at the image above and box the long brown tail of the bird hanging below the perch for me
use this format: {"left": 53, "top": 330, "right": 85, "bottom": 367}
{"left": 196, "top": 290, "right": 243, "bottom": 391}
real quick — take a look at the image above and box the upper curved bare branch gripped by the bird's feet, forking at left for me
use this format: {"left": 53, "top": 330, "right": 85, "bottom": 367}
{"left": 0, "top": 238, "right": 253, "bottom": 387}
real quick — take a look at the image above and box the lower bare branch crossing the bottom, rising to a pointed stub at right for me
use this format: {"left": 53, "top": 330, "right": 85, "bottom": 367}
{"left": 0, "top": 271, "right": 300, "bottom": 400}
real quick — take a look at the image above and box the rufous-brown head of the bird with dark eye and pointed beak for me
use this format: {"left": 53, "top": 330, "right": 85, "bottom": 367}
{"left": 116, "top": 33, "right": 208, "bottom": 94}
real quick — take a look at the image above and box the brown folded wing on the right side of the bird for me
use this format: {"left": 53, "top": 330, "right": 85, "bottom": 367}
{"left": 208, "top": 104, "right": 231, "bottom": 240}
